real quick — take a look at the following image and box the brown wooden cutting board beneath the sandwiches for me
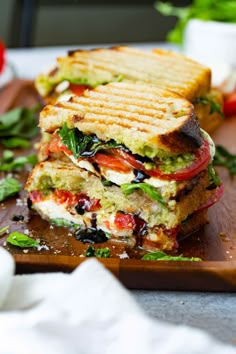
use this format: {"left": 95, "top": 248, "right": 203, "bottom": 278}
{"left": 0, "top": 80, "right": 236, "bottom": 291}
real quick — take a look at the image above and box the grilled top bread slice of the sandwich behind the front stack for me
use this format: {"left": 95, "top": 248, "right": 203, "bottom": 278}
{"left": 36, "top": 47, "right": 211, "bottom": 101}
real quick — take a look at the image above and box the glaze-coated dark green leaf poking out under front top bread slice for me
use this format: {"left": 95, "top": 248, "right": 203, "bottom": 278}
{"left": 58, "top": 123, "right": 124, "bottom": 159}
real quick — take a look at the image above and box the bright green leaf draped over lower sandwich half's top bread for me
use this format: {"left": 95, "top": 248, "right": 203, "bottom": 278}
{"left": 120, "top": 183, "right": 167, "bottom": 209}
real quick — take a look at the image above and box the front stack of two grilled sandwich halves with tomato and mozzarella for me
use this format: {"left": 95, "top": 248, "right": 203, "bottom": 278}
{"left": 26, "top": 83, "right": 223, "bottom": 250}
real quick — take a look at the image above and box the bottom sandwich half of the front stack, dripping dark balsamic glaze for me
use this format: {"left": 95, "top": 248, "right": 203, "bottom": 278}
{"left": 26, "top": 161, "right": 221, "bottom": 250}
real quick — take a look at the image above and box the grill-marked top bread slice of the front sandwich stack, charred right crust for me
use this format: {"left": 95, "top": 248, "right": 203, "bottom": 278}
{"left": 40, "top": 82, "right": 202, "bottom": 157}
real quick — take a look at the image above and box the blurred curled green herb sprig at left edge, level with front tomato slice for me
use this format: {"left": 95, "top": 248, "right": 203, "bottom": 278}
{"left": 0, "top": 150, "right": 37, "bottom": 172}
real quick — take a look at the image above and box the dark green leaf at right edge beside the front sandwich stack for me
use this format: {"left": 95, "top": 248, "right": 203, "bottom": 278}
{"left": 213, "top": 145, "right": 236, "bottom": 176}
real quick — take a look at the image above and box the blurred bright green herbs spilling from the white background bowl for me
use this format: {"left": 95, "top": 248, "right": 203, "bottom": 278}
{"left": 154, "top": 0, "right": 236, "bottom": 44}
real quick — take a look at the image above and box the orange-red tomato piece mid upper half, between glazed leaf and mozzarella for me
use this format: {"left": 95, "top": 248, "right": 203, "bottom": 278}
{"left": 92, "top": 153, "right": 132, "bottom": 173}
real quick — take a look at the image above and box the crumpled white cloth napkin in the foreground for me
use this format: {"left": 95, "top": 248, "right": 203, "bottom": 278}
{"left": 0, "top": 248, "right": 236, "bottom": 354}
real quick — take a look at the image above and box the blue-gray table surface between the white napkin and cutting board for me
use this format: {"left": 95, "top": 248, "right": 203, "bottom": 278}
{"left": 131, "top": 290, "right": 236, "bottom": 345}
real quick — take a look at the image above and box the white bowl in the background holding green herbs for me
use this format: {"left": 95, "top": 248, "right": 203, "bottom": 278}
{"left": 184, "top": 19, "right": 236, "bottom": 85}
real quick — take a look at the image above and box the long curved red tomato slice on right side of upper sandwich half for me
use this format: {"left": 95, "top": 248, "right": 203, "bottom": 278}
{"left": 112, "top": 140, "right": 211, "bottom": 181}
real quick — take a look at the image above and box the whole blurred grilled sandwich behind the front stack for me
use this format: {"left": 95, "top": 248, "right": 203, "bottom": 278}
{"left": 35, "top": 47, "right": 223, "bottom": 131}
